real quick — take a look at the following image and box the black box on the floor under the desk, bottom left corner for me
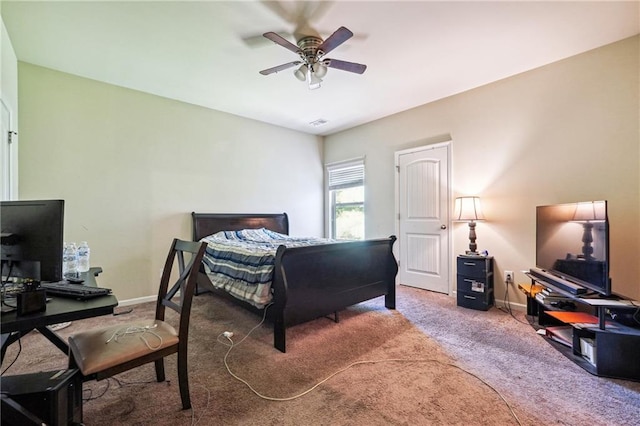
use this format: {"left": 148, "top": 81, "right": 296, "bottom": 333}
{"left": 0, "top": 369, "right": 82, "bottom": 426}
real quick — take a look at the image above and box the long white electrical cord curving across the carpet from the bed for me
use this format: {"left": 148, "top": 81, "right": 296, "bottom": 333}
{"left": 217, "top": 305, "right": 522, "bottom": 425}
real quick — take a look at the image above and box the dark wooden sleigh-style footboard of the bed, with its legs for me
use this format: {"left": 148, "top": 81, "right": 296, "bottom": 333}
{"left": 269, "top": 236, "right": 398, "bottom": 352}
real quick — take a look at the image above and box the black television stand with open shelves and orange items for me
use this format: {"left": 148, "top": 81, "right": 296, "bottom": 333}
{"left": 519, "top": 276, "right": 640, "bottom": 381}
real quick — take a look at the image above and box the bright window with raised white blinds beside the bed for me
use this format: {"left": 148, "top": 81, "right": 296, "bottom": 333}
{"left": 326, "top": 159, "right": 364, "bottom": 240}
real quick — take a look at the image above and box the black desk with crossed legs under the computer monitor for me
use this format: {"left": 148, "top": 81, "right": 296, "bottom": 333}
{"left": 1, "top": 268, "right": 118, "bottom": 359}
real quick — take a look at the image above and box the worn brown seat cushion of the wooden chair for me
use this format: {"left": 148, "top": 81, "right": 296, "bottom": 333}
{"left": 69, "top": 320, "right": 179, "bottom": 376}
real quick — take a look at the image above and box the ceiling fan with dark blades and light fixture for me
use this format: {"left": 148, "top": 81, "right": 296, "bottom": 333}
{"left": 260, "top": 27, "right": 367, "bottom": 89}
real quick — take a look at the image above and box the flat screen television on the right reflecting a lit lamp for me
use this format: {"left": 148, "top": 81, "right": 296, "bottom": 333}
{"left": 531, "top": 201, "right": 611, "bottom": 296}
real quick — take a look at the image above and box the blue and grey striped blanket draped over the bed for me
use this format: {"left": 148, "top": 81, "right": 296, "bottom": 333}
{"left": 200, "top": 228, "right": 336, "bottom": 308}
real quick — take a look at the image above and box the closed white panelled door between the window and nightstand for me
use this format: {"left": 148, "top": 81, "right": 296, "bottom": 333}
{"left": 396, "top": 143, "right": 450, "bottom": 294}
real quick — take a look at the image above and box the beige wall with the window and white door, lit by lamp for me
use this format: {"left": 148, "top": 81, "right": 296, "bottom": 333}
{"left": 325, "top": 36, "right": 640, "bottom": 304}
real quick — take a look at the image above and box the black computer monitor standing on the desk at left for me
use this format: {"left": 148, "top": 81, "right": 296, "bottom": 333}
{"left": 0, "top": 200, "right": 64, "bottom": 282}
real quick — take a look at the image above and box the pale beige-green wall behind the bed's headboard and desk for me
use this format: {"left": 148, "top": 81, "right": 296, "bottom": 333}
{"left": 18, "top": 62, "right": 323, "bottom": 300}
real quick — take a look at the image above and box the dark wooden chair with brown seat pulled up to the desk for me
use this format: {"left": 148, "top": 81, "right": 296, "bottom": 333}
{"left": 69, "top": 239, "right": 206, "bottom": 410}
